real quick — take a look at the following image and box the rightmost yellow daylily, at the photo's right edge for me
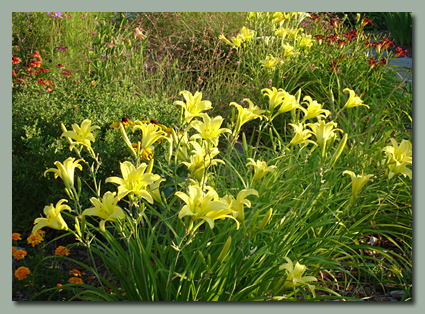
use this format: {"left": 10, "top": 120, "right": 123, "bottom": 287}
{"left": 382, "top": 138, "right": 412, "bottom": 179}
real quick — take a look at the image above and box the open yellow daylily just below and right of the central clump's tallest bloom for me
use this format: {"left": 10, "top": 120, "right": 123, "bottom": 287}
{"left": 190, "top": 113, "right": 232, "bottom": 146}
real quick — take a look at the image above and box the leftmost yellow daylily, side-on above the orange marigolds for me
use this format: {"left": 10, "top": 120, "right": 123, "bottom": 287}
{"left": 32, "top": 199, "right": 71, "bottom": 235}
